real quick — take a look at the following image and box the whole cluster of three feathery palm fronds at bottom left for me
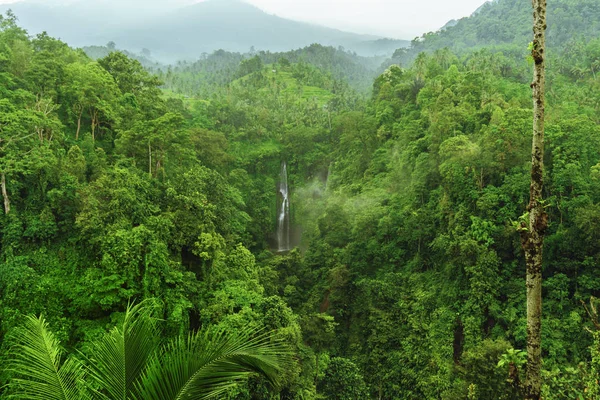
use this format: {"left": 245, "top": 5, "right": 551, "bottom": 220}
{"left": 9, "top": 303, "right": 288, "bottom": 400}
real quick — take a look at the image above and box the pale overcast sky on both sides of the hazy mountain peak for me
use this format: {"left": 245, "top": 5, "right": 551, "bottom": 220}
{"left": 0, "top": 0, "right": 484, "bottom": 39}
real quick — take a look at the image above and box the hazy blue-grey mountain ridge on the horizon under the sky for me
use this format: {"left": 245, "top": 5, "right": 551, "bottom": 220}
{"left": 0, "top": 0, "right": 410, "bottom": 62}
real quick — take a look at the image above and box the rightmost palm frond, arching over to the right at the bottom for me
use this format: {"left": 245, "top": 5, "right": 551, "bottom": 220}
{"left": 139, "top": 331, "right": 290, "bottom": 400}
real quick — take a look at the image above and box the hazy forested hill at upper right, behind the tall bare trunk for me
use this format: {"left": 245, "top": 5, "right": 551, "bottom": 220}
{"left": 386, "top": 0, "right": 600, "bottom": 65}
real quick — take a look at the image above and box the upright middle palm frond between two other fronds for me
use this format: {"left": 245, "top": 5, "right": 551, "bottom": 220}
{"left": 89, "top": 303, "right": 160, "bottom": 400}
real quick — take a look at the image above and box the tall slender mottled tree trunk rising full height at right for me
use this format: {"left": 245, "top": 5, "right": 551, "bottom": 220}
{"left": 521, "top": 0, "right": 548, "bottom": 400}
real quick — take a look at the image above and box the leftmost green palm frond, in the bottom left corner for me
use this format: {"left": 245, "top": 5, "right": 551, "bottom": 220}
{"left": 8, "top": 316, "right": 91, "bottom": 400}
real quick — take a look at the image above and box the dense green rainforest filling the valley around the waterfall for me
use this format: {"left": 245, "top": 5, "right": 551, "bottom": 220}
{"left": 0, "top": 0, "right": 600, "bottom": 400}
